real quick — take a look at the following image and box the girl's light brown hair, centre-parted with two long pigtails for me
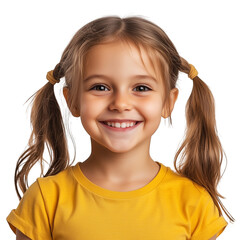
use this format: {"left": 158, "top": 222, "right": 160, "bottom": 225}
{"left": 14, "top": 16, "right": 234, "bottom": 221}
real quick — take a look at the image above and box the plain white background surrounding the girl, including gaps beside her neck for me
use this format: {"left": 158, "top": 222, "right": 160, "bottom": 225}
{"left": 0, "top": 0, "right": 240, "bottom": 239}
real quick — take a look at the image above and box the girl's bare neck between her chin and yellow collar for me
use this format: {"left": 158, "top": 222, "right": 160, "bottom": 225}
{"left": 82, "top": 139, "right": 159, "bottom": 182}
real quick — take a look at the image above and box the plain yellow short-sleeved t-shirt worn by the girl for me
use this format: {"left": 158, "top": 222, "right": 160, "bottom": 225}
{"left": 7, "top": 162, "right": 227, "bottom": 240}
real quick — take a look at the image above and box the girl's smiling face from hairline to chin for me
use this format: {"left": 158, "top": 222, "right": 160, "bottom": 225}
{"left": 73, "top": 41, "right": 177, "bottom": 152}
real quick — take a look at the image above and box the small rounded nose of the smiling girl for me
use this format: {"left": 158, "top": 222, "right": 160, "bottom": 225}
{"left": 109, "top": 92, "right": 132, "bottom": 112}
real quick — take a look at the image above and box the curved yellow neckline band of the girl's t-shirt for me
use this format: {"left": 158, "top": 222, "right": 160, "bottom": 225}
{"left": 71, "top": 161, "right": 168, "bottom": 199}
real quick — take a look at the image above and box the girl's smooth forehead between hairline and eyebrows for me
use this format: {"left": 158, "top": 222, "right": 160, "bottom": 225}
{"left": 84, "top": 40, "right": 155, "bottom": 76}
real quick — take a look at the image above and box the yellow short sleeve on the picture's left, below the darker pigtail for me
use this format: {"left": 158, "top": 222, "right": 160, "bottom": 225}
{"left": 6, "top": 180, "right": 52, "bottom": 240}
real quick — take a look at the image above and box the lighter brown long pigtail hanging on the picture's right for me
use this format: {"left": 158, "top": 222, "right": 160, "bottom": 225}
{"left": 174, "top": 58, "right": 234, "bottom": 221}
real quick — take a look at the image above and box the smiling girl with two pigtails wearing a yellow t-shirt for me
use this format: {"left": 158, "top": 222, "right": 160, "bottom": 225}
{"left": 7, "top": 16, "right": 234, "bottom": 240}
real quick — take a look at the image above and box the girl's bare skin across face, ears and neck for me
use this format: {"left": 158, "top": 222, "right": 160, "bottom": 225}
{"left": 63, "top": 41, "right": 178, "bottom": 186}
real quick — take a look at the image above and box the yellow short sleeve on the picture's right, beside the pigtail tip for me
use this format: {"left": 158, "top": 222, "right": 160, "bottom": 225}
{"left": 191, "top": 192, "right": 227, "bottom": 240}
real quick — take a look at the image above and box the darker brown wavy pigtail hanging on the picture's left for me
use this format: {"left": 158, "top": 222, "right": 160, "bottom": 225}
{"left": 14, "top": 64, "right": 69, "bottom": 200}
